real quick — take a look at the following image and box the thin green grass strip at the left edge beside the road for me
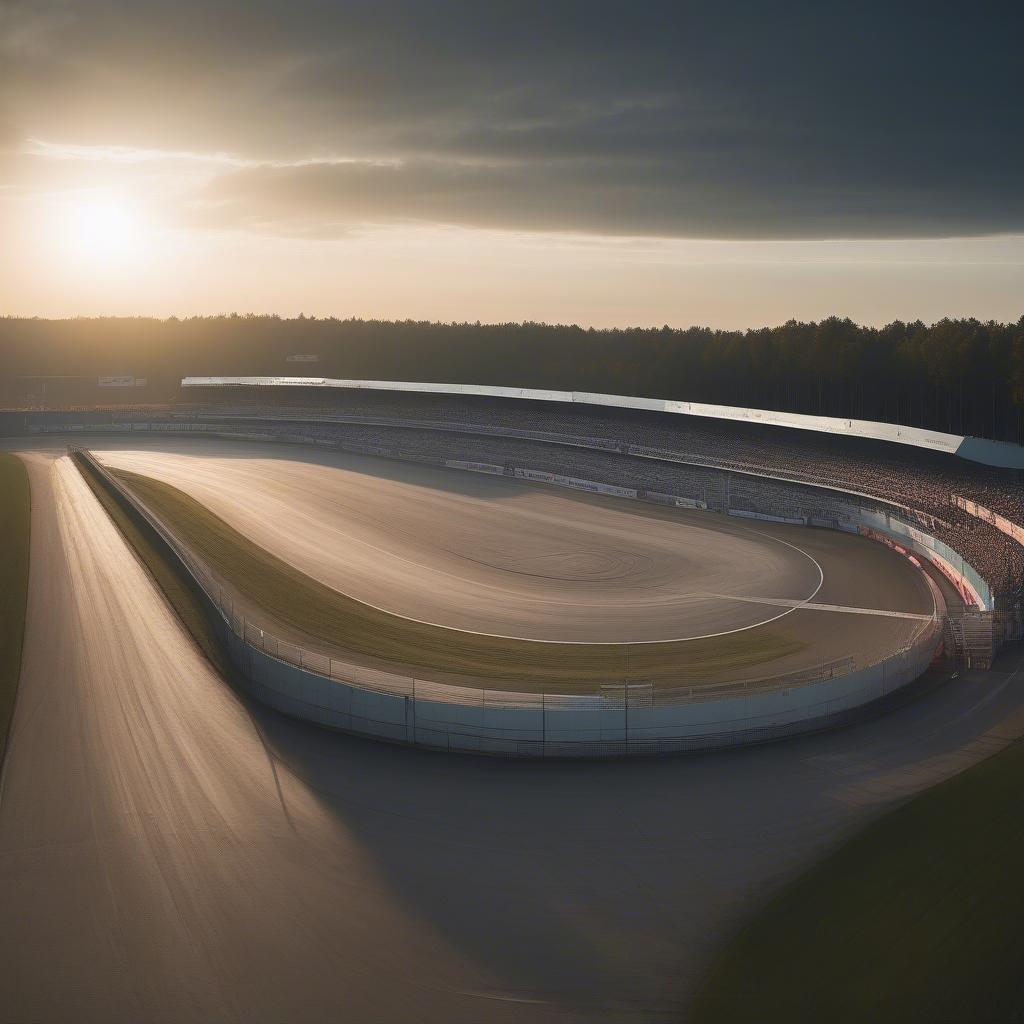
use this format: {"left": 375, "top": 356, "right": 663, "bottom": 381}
{"left": 0, "top": 453, "right": 32, "bottom": 763}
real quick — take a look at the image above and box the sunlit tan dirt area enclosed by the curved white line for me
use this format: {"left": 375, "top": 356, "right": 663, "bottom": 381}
{"left": 101, "top": 442, "right": 819, "bottom": 641}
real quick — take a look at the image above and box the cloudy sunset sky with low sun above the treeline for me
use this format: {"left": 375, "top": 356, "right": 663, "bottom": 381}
{"left": 0, "top": 0, "right": 1024, "bottom": 328}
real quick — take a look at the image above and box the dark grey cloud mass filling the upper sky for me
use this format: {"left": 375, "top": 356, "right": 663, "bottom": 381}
{"left": 8, "top": 0, "right": 1024, "bottom": 238}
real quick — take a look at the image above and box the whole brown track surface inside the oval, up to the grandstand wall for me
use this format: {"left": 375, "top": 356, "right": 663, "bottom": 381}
{"left": 98, "top": 440, "right": 933, "bottom": 677}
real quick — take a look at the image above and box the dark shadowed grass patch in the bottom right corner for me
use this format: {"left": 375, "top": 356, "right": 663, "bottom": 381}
{"left": 687, "top": 729, "right": 1024, "bottom": 1024}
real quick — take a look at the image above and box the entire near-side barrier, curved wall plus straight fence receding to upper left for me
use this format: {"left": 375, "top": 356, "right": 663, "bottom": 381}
{"left": 70, "top": 452, "right": 944, "bottom": 758}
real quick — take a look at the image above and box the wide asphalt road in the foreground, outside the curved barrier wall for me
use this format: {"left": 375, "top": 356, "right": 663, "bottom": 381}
{"left": 0, "top": 442, "right": 1024, "bottom": 1024}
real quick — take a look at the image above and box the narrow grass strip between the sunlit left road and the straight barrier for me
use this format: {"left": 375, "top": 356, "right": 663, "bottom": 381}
{"left": 72, "top": 453, "right": 230, "bottom": 678}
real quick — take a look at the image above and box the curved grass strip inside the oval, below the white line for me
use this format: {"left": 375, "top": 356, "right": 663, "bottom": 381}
{"left": 115, "top": 470, "right": 805, "bottom": 692}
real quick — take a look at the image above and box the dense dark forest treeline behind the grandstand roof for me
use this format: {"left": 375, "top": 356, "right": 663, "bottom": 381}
{"left": 0, "top": 314, "right": 1024, "bottom": 443}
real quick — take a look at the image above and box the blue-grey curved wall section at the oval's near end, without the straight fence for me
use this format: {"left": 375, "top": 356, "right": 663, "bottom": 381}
{"left": 214, "top": 623, "right": 940, "bottom": 758}
